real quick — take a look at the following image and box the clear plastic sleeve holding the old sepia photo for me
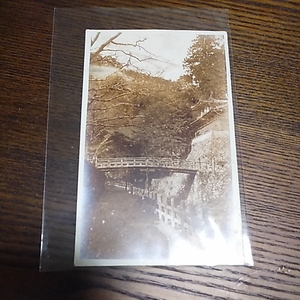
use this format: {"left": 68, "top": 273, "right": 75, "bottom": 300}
{"left": 40, "top": 8, "right": 253, "bottom": 271}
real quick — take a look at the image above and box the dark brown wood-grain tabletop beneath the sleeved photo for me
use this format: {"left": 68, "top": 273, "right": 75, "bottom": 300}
{"left": 0, "top": 0, "right": 300, "bottom": 299}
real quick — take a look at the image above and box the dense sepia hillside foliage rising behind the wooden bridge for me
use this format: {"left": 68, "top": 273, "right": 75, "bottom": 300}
{"left": 87, "top": 70, "right": 192, "bottom": 161}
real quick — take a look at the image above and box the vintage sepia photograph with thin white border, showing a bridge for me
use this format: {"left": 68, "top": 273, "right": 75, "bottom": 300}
{"left": 75, "top": 30, "right": 244, "bottom": 266}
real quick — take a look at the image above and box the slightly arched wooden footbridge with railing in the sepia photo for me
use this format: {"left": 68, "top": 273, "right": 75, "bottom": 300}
{"left": 95, "top": 157, "right": 199, "bottom": 173}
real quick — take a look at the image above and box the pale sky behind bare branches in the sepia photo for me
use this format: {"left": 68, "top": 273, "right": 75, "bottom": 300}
{"left": 89, "top": 30, "right": 224, "bottom": 80}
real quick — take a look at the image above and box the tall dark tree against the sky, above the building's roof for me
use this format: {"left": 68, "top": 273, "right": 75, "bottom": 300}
{"left": 183, "top": 35, "right": 227, "bottom": 100}
